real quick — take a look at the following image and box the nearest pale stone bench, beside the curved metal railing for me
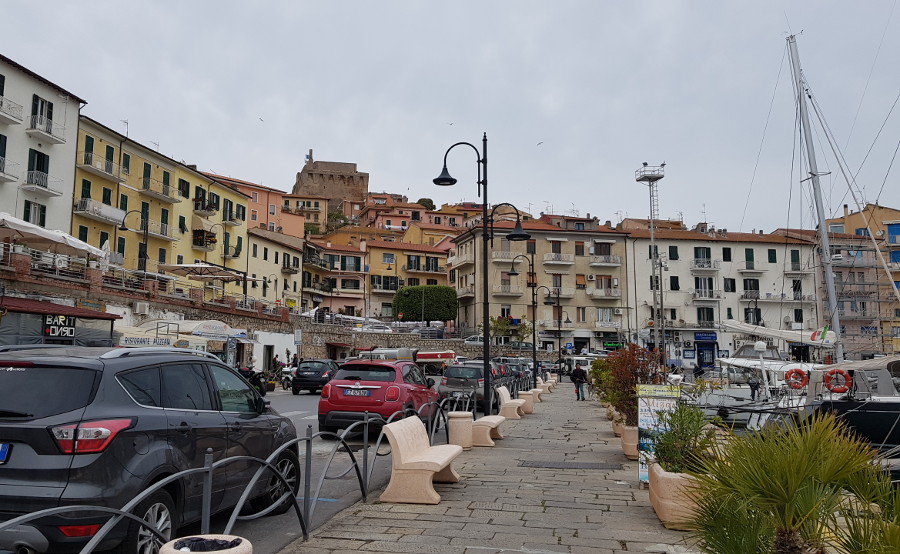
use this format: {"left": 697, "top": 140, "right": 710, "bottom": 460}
{"left": 381, "top": 416, "right": 463, "bottom": 504}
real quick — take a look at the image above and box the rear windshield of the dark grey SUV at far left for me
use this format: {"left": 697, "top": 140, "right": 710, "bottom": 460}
{"left": 0, "top": 361, "right": 97, "bottom": 418}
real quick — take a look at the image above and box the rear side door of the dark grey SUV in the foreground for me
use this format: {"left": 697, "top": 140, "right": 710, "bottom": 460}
{"left": 161, "top": 362, "right": 228, "bottom": 519}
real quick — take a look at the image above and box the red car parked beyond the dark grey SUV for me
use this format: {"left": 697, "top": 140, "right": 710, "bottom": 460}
{"left": 319, "top": 360, "right": 439, "bottom": 433}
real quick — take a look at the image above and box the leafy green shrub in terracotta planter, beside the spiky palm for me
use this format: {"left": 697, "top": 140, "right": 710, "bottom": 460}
{"left": 648, "top": 402, "right": 717, "bottom": 529}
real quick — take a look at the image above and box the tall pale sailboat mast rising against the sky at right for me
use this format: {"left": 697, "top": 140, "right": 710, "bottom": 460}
{"left": 787, "top": 35, "right": 844, "bottom": 362}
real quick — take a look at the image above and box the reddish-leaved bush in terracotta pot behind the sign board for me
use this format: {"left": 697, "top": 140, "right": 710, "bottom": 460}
{"left": 607, "top": 343, "right": 659, "bottom": 460}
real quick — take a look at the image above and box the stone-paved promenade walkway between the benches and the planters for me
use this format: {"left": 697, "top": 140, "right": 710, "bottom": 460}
{"left": 279, "top": 382, "right": 689, "bottom": 554}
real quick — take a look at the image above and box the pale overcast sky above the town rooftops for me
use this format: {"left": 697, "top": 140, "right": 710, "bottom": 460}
{"left": 0, "top": 0, "right": 900, "bottom": 231}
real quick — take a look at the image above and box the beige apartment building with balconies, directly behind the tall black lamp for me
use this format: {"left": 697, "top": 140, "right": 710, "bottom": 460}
{"left": 448, "top": 215, "right": 627, "bottom": 351}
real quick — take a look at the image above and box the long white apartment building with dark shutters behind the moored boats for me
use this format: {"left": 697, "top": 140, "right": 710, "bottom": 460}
{"left": 619, "top": 219, "right": 821, "bottom": 368}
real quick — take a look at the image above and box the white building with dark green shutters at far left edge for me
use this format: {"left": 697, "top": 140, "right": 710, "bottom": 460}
{"left": 0, "top": 55, "right": 86, "bottom": 233}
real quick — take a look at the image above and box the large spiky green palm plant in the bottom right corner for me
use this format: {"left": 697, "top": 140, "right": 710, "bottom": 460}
{"left": 692, "top": 413, "right": 900, "bottom": 554}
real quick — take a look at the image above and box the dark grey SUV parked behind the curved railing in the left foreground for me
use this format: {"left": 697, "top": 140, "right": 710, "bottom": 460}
{"left": 0, "top": 345, "right": 300, "bottom": 554}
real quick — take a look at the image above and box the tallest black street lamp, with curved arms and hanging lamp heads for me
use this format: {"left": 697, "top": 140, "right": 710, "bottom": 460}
{"left": 432, "top": 133, "right": 529, "bottom": 415}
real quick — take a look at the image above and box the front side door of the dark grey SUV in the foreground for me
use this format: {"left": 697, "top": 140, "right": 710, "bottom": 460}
{"left": 207, "top": 364, "right": 280, "bottom": 506}
